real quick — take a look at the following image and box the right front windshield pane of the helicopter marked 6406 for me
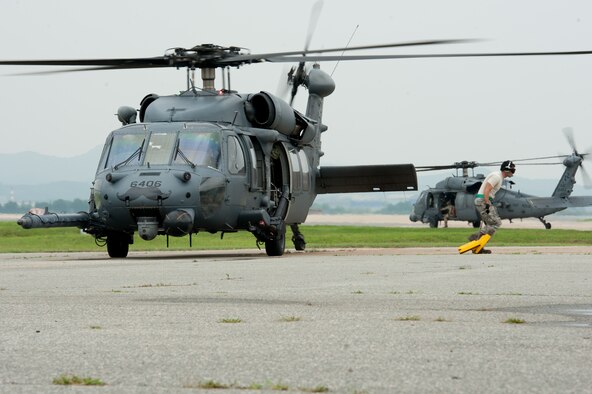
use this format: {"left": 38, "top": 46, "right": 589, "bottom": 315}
{"left": 174, "top": 131, "right": 220, "bottom": 168}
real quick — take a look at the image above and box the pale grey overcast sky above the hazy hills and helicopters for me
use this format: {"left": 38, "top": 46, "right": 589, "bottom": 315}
{"left": 0, "top": 0, "right": 592, "bottom": 182}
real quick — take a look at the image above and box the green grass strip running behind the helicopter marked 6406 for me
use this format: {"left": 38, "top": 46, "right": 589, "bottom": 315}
{"left": 0, "top": 222, "right": 592, "bottom": 253}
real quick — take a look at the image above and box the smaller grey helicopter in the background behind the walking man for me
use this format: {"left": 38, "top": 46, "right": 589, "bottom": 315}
{"left": 409, "top": 128, "right": 592, "bottom": 230}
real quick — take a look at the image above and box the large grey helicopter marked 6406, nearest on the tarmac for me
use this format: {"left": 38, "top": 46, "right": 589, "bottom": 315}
{"left": 0, "top": 37, "right": 592, "bottom": 258}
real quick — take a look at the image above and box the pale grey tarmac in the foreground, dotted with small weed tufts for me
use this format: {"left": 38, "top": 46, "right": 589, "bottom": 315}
{"left": 0, "top": 247, "right": 592, "bottom": 394}
